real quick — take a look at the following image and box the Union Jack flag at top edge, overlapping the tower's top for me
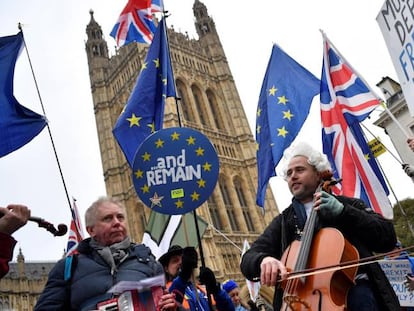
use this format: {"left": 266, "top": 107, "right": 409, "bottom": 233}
{"left": 110, "top": 0, "right": 163, "bottom": 47}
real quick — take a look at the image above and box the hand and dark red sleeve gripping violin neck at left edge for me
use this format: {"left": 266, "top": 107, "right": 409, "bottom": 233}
{"left": 0, "top": 204, "right": 30, "bottom": 278}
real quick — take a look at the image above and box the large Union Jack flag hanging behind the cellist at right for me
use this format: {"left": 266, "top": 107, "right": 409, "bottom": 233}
{"left": 320, "top": 35, "right": 393, "bottom": 219}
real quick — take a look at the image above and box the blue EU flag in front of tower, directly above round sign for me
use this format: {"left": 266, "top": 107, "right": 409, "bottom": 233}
{"left": 113, "top": 19, "right": 176, "bottom": 168}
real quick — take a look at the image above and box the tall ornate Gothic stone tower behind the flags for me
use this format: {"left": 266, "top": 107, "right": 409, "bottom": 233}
{"left": 86, "top": 0, "right": 278, "bottom": 282}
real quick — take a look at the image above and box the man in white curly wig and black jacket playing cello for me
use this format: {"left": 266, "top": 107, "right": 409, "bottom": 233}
{"left": 241, "top": 143, "right": 399, "bottom": 311}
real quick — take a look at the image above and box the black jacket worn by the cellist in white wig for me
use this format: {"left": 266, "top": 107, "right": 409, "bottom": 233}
{"left": 240, "top": 196, "right": 399, "bottom": 310}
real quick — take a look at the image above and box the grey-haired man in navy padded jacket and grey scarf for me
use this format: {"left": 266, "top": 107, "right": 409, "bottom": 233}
{"left": 34, "top": 197, "right": 177, "bottom": 311}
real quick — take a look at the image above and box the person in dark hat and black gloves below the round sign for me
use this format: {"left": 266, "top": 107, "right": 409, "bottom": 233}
{"left": 164, "top": 246, "right": 234, "bottom": 311}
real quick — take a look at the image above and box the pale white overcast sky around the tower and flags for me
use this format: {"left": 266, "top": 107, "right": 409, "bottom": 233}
{"left": 0, "top": 0, "right": 414, "bottom": 261}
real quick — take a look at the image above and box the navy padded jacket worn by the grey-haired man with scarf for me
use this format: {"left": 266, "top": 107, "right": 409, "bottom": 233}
{"left": 34, "top": 238, "right": 164, "bottom": 311}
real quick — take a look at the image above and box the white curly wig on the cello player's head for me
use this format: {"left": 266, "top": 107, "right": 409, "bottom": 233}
{"left": 279, "top": 142, "right": 332, "bottom": 180}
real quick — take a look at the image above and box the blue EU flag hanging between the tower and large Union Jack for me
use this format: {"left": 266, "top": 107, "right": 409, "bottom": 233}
{"left": 256, "top": 45, "right": 320, "bottom": 207}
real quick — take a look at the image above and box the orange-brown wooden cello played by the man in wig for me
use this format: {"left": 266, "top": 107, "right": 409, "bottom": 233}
{"left": 280, "top": 173, "right": 359, "bottom": 311}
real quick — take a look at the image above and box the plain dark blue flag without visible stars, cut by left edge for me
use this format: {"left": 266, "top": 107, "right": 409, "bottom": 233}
{"left": 0, "top": 32, "right": 47, "bottom": 157}
